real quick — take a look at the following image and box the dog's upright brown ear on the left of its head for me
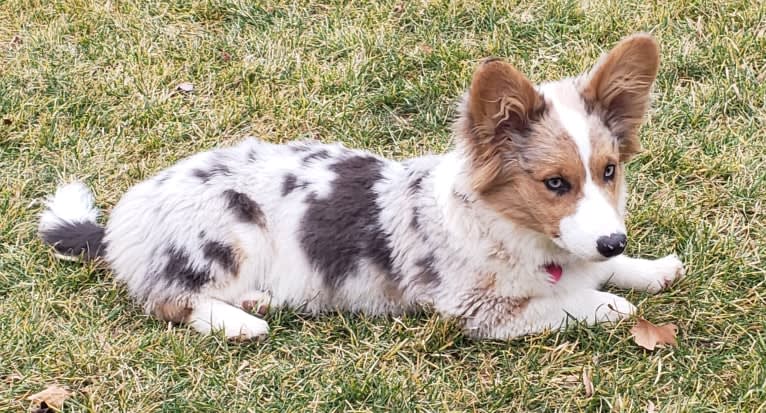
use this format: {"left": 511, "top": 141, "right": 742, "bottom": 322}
{"left": 465, "top": 59, "right": 545, "bottom": 192}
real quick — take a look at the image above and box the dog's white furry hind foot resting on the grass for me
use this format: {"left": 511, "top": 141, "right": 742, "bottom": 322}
{"left": 185, "top": 298, "right": 269, "bottom": 339}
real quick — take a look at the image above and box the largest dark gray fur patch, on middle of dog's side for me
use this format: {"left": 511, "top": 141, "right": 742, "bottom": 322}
{"left": 301, "top": 155, "right": 400, "bottom": 288}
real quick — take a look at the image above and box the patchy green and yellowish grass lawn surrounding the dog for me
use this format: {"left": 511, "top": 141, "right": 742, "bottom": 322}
{"left": 0, "top": 0, "right": 766, "bottom": 412}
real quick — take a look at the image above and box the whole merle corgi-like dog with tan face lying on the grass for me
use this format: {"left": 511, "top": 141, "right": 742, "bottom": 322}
{"left": 39, "top": 34, "right": 683, "bottom": 339}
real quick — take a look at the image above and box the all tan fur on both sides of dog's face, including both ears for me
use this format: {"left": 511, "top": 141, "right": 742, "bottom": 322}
{"left": 458, "top": 35, "right": 659, "bottom": 238}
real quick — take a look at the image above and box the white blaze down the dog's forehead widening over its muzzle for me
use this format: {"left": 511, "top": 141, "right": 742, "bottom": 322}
{"left": 546, "top": 87, "right": 625, "bottom": 260}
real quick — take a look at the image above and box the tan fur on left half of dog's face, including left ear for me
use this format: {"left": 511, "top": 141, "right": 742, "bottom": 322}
{"left": 464, "top": 61, "right": 585, "bottom": 237}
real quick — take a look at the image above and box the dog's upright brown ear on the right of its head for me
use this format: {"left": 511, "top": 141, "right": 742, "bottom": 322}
{"left": 580, "top": 33, "right": 660, "bottom": 162}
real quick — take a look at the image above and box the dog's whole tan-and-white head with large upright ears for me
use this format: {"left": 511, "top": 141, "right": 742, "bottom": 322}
{"left": 457, "top": 34, "right": 659, "bottom": 261}
